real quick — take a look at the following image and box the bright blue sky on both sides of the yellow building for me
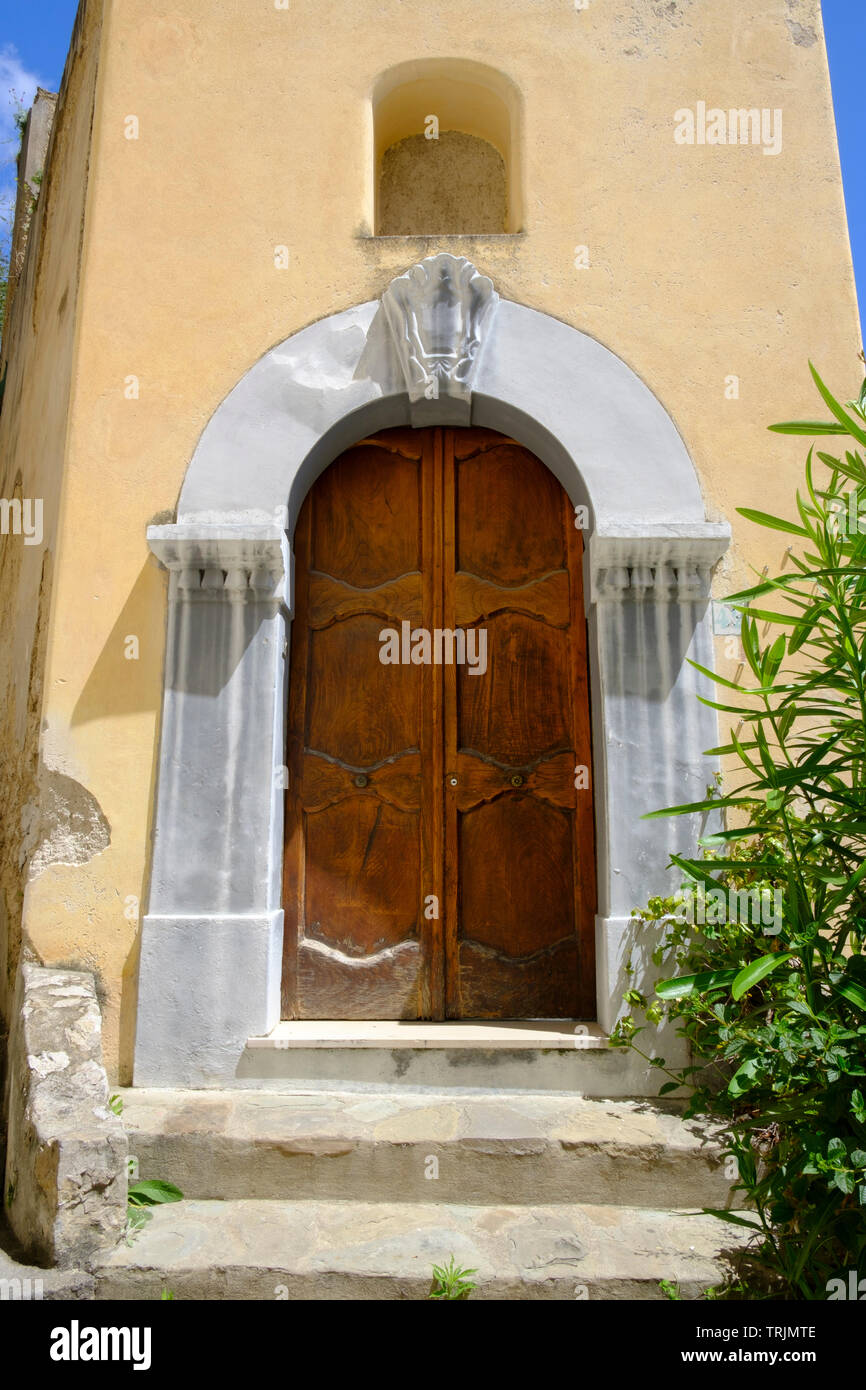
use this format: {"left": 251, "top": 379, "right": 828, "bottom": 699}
{"left": 0, "top": 0, "right": 866, "bottom": 322}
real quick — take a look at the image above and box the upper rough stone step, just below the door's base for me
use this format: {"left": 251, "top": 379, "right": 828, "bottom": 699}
{"left": 120, "top": 1090, "right": 730, "bottom": 1208}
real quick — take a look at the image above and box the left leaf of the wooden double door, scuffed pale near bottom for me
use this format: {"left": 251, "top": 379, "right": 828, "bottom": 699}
{"left": 282, "top": 430, "right": 441, "bottom": 1019}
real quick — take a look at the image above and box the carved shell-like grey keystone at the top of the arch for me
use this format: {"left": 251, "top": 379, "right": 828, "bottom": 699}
{"left": 382, "top": 252, "right": 499, "bottom": 424}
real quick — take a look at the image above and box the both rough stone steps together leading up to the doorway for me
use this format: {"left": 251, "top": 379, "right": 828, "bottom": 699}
{"left": 95, "top": 1088, "right": 740, "bottom": 1300}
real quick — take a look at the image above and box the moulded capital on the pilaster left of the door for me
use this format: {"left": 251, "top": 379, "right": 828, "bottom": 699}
{"left": 147, "top": 525, "right": 292, "bottom": 610}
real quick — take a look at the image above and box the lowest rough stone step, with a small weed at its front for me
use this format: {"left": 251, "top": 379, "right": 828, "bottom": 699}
{"left": 93, "top": 1201, "right": 738, "bottom": 1300}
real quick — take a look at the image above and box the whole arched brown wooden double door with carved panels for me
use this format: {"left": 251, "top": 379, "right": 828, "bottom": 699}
{"left": 284, "top": 428, "right": 595, "bottom": 1019}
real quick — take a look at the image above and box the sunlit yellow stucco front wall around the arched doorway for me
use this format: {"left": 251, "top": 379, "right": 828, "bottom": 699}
{"left": 6, "top": 0, "right": 860, "bottom": 1076}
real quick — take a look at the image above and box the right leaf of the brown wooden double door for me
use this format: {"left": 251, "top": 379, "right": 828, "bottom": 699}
{"left": 445, "top": 430, "right": 594, "bottom": 1019}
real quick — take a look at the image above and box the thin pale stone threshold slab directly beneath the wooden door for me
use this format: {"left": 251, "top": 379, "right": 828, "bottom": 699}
{"left": 246, "top": 1019, "right": 610, "bottom": 1052}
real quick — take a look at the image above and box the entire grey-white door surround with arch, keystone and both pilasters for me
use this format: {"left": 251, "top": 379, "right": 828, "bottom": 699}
{"left": 135, "top": 257, "right": 728, "bottom": 1086}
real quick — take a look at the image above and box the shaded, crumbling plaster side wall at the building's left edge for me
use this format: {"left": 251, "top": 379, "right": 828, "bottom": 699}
{"left": 0, "top": 0, "right": 108, "bottom": 1073}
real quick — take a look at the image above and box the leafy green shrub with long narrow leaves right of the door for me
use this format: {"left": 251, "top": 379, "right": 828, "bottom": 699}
{"left": 617, "top": 368, "right": 866, "bottom": 1300}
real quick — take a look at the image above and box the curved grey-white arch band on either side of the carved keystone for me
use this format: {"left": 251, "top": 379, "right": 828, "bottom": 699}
{"left": 178, "top": 300, "right": 705, "bottom": 531}
